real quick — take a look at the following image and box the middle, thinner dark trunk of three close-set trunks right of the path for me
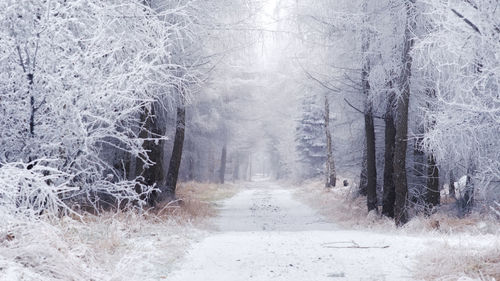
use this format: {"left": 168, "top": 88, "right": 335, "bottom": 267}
{"left": 382, "top": 90, "right": 396, "bottom": 218}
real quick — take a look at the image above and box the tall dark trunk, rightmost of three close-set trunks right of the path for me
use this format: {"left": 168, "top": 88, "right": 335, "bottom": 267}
{"left": 393, "top": 0, "right": 415, "bottom": 226}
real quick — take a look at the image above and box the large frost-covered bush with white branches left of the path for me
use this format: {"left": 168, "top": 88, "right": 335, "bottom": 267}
{"left": 0, "top": 0, "right": 196, "bottom": 213}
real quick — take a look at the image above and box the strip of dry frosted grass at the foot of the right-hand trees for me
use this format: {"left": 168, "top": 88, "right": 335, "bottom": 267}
{"left": 296, "top": 177, "right": 500, "bottom": 235}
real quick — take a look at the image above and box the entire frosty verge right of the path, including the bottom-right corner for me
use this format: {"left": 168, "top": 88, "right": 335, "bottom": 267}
{"left": 290, "top": 178, "right": 500, "bottom": 280}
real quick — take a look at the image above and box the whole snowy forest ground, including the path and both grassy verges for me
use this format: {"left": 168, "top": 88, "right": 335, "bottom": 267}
{"left": 0, "top": 180, "right": 500, "bottom": 281}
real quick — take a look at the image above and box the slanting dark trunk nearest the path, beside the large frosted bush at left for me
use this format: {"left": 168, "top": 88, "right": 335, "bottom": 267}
{"left": 161, "top": 104, "right": 186, "bottom": 200}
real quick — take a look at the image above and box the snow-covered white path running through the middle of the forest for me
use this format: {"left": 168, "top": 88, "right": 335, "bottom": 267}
{"left": 167, "top": 182, "right": 424, "bottom": 281}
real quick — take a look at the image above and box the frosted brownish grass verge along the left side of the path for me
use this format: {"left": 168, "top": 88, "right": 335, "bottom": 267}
{"left": 0, "top": 183, "right": 237, "bottom": 281}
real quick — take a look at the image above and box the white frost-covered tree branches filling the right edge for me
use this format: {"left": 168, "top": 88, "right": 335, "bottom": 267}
{"left": 414, "top": 1, "right": 500, "bottom": 211}
